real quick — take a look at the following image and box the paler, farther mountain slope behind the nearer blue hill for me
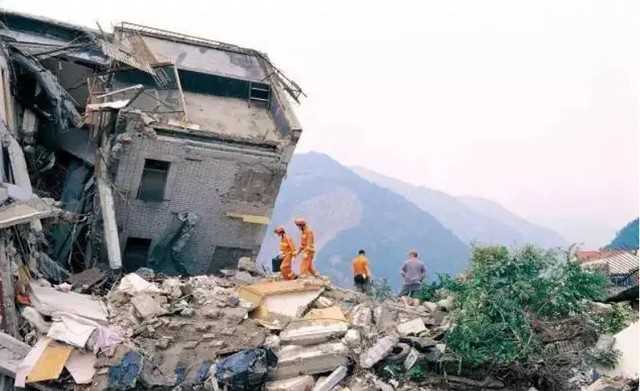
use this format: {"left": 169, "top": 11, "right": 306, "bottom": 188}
{"left": 354, "top": 167, "right": 566, "bottom": 247}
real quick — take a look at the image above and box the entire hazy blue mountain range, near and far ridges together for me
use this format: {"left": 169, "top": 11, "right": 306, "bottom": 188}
{"left": 258, "top": 152, "right": 565, "bottom": 288}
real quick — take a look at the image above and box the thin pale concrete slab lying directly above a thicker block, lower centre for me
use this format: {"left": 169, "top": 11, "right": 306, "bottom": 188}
{"left": 280, "top": 320, "right": 348, "bottom": 345}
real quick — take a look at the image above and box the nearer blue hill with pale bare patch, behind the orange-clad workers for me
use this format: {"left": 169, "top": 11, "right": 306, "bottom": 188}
{"left": 258, "top": 153, "right": 469, "bottom": 288}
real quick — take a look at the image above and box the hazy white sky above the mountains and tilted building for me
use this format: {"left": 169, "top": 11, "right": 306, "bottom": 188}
{"left": 5, "top": 0, "right": 640, "bottom": 246}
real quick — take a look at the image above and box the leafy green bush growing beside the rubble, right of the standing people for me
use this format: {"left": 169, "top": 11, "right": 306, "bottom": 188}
{"left": 444, "top": 246, "right": 606, "bottom": 366}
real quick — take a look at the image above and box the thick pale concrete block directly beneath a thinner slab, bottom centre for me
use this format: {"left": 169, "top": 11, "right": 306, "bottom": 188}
{"left": 273, "top": 342, "right": 349, "bottom": 379}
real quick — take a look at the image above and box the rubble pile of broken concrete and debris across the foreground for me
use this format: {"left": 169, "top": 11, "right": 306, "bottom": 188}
{"left": 0, "top": 262, "right": 637, "bottom": 391}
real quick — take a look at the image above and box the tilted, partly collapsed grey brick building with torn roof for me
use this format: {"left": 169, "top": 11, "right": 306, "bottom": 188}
{"left": 0, "top": 12, "right": 302, "bottom": 274}
